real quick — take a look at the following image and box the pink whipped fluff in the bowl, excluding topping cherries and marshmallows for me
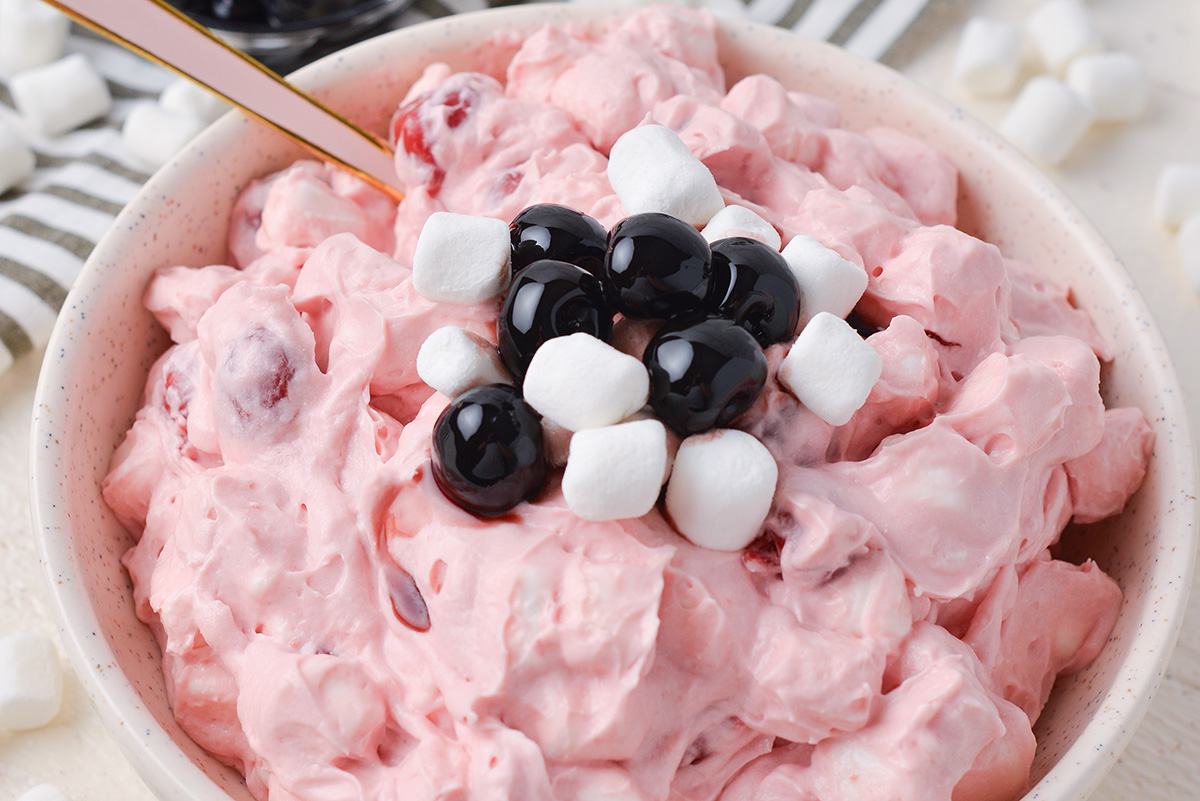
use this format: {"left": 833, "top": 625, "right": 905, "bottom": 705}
{"left": 104, "top": 10, "right": 1153, "bottom": 801}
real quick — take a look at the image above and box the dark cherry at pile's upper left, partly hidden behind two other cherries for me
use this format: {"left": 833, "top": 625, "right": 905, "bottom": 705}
{"left": 509, "top": 203, "right": 608, "bottom": 277}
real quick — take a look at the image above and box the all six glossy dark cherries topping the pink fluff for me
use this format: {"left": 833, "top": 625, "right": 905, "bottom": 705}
{"left": 433, "top": 204, "right": 800, "bottom": 516}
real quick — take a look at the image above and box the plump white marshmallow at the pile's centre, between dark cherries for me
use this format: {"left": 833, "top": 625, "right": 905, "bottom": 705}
{"left": 523, "top": 333, "right": 650, "bottom": 432}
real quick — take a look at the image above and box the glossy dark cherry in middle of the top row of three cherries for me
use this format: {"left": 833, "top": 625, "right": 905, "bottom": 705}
{"left": 604, "top": 212, "right": 713, "bottom": 319}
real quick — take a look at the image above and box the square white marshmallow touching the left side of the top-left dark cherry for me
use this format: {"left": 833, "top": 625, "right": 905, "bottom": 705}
{"left": 413, "top": 211, "right": 511, "bottom": 305}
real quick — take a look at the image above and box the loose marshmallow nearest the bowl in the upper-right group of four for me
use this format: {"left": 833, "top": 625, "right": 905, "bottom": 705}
{"left": 1000, "top": 76, "right": 1092, "bottom": 164}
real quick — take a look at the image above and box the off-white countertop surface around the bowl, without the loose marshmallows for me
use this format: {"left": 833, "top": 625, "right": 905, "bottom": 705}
{"left": 0, "top": 0, "right": 1200, "bottom": 801}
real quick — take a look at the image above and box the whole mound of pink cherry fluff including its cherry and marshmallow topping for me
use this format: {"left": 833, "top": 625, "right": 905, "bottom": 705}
{"left": 103, "top": 8, "right": 1153, "bottom": 801}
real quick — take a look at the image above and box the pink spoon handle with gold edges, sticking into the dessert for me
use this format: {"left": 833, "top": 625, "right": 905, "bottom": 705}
{"left": 47, "top": 0, "right": 403, "bottom": 201}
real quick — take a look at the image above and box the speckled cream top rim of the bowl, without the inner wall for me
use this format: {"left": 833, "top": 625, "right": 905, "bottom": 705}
{"left": 30, "top": 5, "right": 1196, "bottom": 801}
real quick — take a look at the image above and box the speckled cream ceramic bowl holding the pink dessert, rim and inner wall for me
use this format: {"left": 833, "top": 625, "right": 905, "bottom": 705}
{"left": 31, "top": 5, "right": 1196, "bottom": 801}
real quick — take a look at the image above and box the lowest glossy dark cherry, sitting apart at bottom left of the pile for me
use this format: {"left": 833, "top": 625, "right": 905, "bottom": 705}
{"left": 433, "top": 384, "right": 546, "bottom": 517}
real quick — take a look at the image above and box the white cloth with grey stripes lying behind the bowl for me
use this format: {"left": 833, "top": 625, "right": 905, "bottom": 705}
{"left": 0, "top": 0, "right": 929, "bottom": 372}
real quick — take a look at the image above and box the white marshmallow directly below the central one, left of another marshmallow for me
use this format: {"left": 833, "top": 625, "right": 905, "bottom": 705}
{"left": 563, "top": 420, "right": 667, "bottom": 520}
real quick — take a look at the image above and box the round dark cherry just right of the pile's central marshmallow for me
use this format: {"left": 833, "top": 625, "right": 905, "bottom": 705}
{"left": 642, "top": 314, "right": 767, "bottom": 436}
